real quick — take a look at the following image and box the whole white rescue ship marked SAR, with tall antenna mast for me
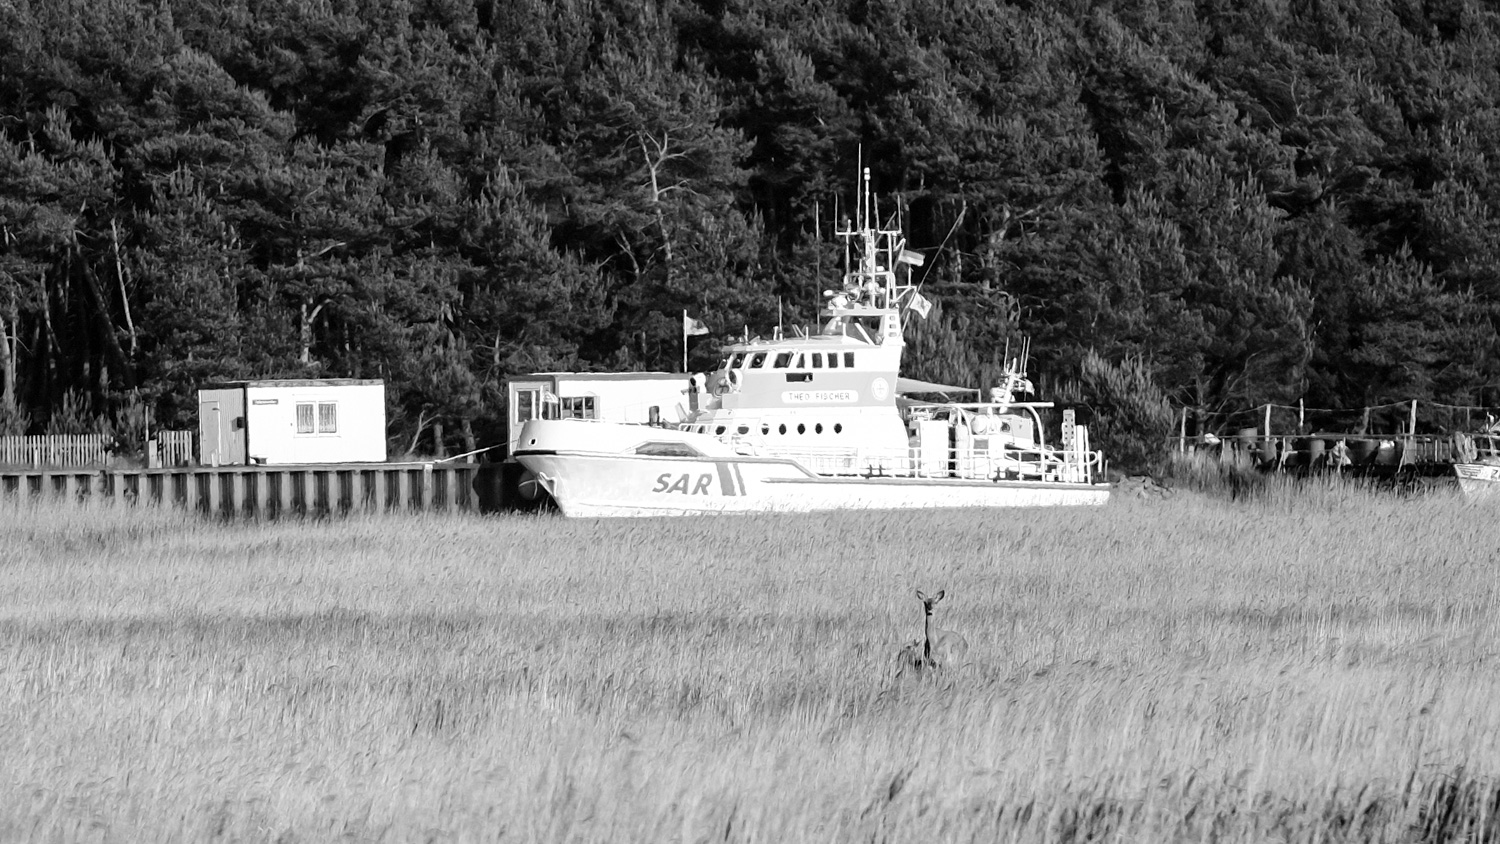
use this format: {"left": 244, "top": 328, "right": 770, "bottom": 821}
{"left": 513, "top": 169, "right": 1110, "bottom": 516}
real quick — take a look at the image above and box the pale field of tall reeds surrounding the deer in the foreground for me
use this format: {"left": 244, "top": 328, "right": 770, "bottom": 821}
{"left": 0, "top": 484, "right": 1500, "bottom": 843}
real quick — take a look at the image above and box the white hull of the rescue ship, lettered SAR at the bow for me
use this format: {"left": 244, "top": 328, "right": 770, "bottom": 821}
{"left": 518, "top": 440, "right": 1110, "bottom": 517}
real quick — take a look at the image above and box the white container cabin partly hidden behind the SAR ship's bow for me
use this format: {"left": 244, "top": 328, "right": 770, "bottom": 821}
{"left": 506, "top": 372, "right": 708, "bottom": 454}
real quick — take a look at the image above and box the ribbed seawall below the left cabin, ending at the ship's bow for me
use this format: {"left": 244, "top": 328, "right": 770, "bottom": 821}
{"left": 0, "top": 463, "right": 492, "bottom": 519}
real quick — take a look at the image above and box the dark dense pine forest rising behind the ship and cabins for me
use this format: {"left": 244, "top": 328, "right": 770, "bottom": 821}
{"left": 0, "top": 0, "right": 1500, "bottom": 453}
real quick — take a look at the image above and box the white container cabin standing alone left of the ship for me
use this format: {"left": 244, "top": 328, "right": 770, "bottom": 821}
{"left": 198, "top": 378, "right": 386, "bottom": 466}
